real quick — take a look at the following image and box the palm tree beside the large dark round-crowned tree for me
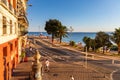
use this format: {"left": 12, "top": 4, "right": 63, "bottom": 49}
{"left": 56, "top": 26, "right": 68, "bottom": 43}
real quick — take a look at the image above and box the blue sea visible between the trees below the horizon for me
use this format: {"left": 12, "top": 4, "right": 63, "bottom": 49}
{"left": 28, "top": 32, "right": 111, "bottom": 45}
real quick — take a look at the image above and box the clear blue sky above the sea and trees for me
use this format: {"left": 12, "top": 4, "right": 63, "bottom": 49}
{"left": 27, "top": 0, "right": 120, "bottom": 32}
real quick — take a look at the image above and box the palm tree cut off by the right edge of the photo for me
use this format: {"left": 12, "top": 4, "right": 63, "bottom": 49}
{"left": 112, "top": 28, "right": 120, "bottom": 54}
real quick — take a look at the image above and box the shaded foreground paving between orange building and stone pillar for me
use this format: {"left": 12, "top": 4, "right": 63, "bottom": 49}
{"left": 11, "top": 57, "right": 33, "bottom": 80}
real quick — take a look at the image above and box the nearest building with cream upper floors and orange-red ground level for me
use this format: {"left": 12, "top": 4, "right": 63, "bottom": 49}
{"left": 0, "top": 0, "right": 28, "bottom": 80}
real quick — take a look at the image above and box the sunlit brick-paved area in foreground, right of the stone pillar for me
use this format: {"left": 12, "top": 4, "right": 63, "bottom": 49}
{"left": 43, "top": 62, "right": 108, "bottom": 80}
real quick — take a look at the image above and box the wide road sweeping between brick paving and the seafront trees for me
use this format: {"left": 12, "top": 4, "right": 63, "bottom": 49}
{"left": 28, "top": 36, "right": 120, "bottom": 80}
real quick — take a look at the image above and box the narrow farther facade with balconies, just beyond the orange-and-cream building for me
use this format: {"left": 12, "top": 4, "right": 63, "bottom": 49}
{"left": 17, "top": 0, "right": 29, "bottom": 61}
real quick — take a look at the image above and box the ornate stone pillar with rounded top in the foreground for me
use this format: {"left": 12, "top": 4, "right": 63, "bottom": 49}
{"left": 32, "top": 50, "right": 42, "bottom": 80}
